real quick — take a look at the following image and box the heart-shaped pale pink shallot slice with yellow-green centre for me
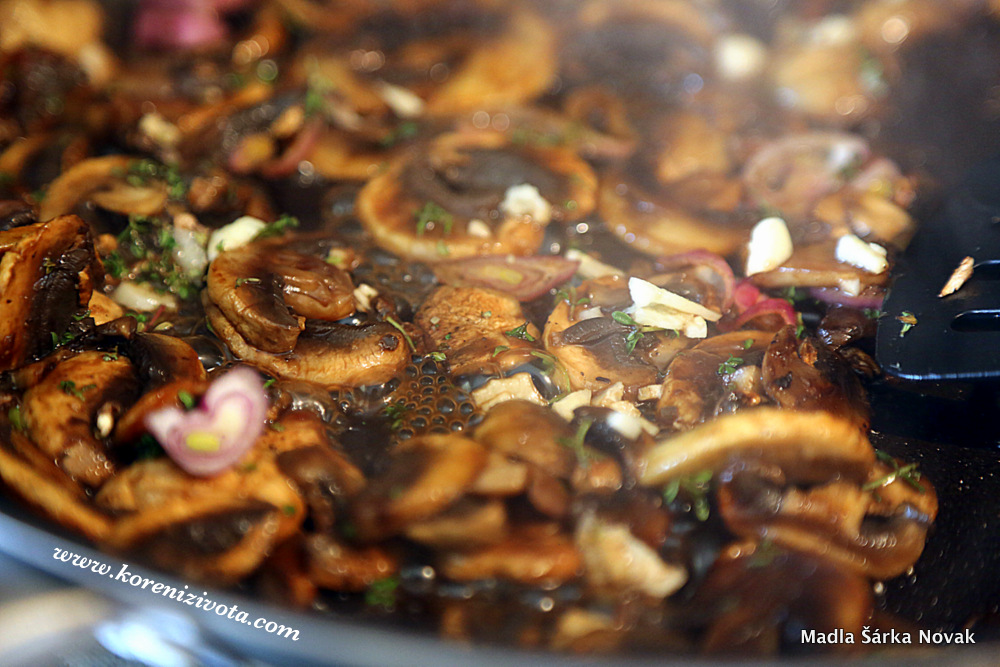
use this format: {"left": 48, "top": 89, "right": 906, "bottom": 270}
{"left": 144, "top": 366, "right": 268, "bottom": 477}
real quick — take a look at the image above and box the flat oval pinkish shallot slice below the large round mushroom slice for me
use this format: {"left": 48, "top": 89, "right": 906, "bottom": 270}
{"left": 434, "top": 255, "right": 580, "bottom": 301}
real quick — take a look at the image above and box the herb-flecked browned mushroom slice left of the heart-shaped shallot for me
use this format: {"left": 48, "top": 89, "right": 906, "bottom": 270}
{"left": 23, "top": 352, "right": 138, "bottom": 486}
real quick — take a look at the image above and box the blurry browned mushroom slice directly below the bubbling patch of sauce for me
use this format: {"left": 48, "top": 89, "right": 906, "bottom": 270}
{"left": 351, "top": 435, "right": 487, "bottom": 540}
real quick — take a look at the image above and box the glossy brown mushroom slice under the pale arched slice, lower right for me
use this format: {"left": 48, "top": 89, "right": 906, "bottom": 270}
{"left": 718, "top": 465, "right": 937, "bottom": 579}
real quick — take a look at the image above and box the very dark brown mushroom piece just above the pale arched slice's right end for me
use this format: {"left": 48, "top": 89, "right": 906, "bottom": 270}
{"left": 761, "top": 327, "right": 868, "bottom": 430}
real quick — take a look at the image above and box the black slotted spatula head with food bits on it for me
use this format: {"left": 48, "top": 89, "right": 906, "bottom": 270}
{"left": 876, "top": 156, "right": 1000, "bottom": 380}
